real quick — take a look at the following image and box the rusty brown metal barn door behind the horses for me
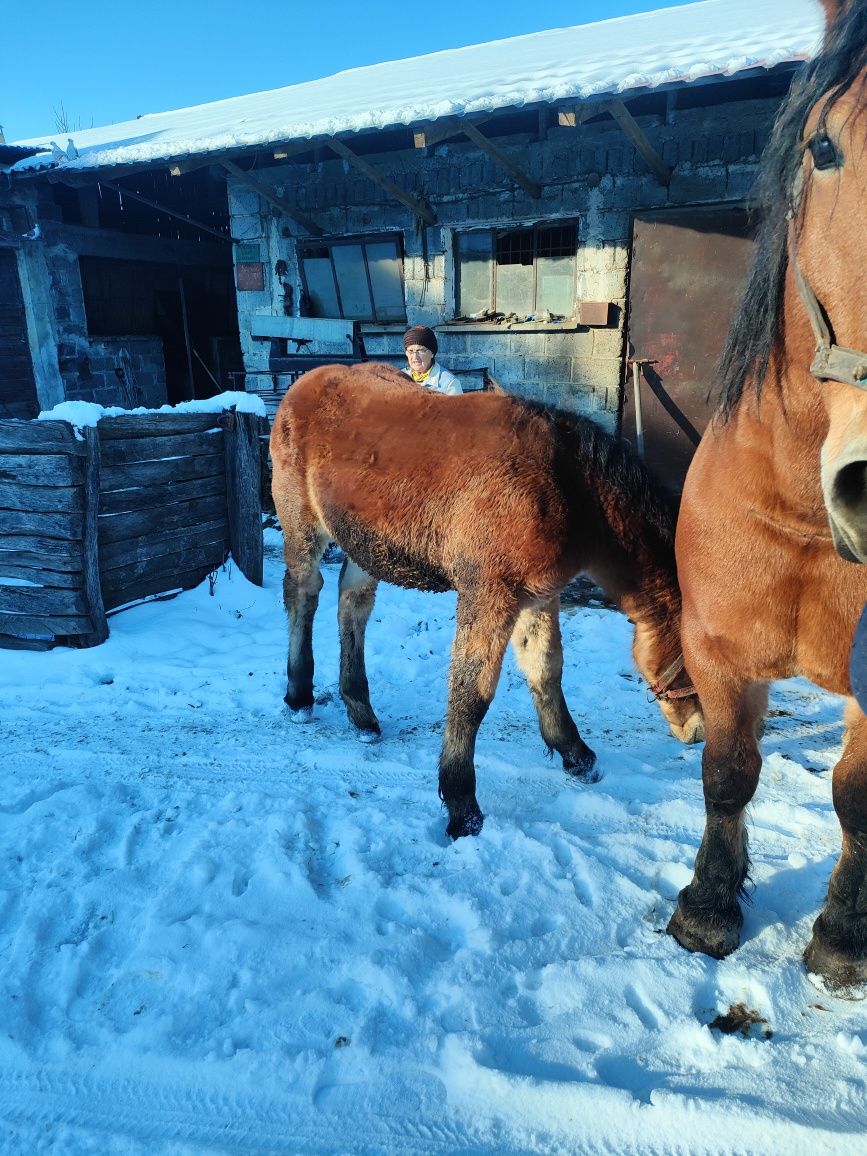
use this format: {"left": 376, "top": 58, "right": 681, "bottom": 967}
{"left": 622, "top": 208, "right": 753, "bottom": 492}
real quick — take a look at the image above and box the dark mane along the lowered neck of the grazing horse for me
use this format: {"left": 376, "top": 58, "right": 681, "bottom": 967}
{"left": 513, "top": 398, "right": 679, "bottom": 547}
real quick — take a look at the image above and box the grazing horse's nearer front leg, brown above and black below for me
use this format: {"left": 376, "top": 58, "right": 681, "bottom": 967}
{"left": 439, "top": 588, "right": 518, "bottom": 839}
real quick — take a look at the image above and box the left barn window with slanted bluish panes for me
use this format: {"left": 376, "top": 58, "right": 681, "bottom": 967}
{"left": 298, "top": 236, "right": 407, "bottom": 321}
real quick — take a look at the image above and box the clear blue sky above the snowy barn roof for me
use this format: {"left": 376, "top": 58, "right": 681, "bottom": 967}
{"left": 0, "top": 0, "right": 698, "bottom": 141}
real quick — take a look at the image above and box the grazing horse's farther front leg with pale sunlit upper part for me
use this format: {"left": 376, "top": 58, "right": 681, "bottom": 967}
{"left": 512, "top": 598, "right": 601, "bottom": 783}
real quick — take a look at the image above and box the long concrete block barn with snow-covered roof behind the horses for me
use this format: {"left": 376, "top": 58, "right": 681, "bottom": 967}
{"left": 0, "top": 0, "right": 822, "bottom": 484}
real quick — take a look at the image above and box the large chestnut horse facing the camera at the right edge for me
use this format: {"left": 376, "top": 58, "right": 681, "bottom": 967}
{"left": 668, "top": 0, "right": 867, "bottom": 988}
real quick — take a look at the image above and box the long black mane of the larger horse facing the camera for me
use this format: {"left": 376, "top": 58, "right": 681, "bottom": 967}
{"left": 718, "top": 0, "right": 867, "bottom": 421}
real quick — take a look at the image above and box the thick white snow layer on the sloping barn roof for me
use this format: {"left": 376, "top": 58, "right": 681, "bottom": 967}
{"left": 14, "top": 0, "right": 823, "bottom": 172}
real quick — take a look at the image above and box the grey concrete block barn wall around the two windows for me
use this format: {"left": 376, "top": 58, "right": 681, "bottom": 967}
{"left": 229, "top": 92, "right": 778, "bottom": 428}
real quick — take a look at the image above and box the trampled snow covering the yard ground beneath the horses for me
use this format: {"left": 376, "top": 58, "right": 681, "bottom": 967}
{"left": 0, "top": 531, "right": 867, "bottom": 1156}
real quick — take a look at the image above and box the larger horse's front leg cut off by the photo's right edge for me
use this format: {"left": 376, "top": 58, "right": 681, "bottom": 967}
{"left": 803, "top": 711, "right": 867, "bottom": 987}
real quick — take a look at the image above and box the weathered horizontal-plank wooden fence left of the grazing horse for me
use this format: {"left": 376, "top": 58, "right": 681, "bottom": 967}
{"left": 0, "top": 410, "right": 267, "bottom": 650}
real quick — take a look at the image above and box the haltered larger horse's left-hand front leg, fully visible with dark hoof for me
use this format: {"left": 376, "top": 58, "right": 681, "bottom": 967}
{"left": 668, "top": 662, "right": 768, "bottom": 959}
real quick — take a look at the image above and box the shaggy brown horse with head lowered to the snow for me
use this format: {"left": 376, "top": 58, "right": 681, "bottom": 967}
{"left": 271, "top": 363, "right": 703, "bottom": 838}
